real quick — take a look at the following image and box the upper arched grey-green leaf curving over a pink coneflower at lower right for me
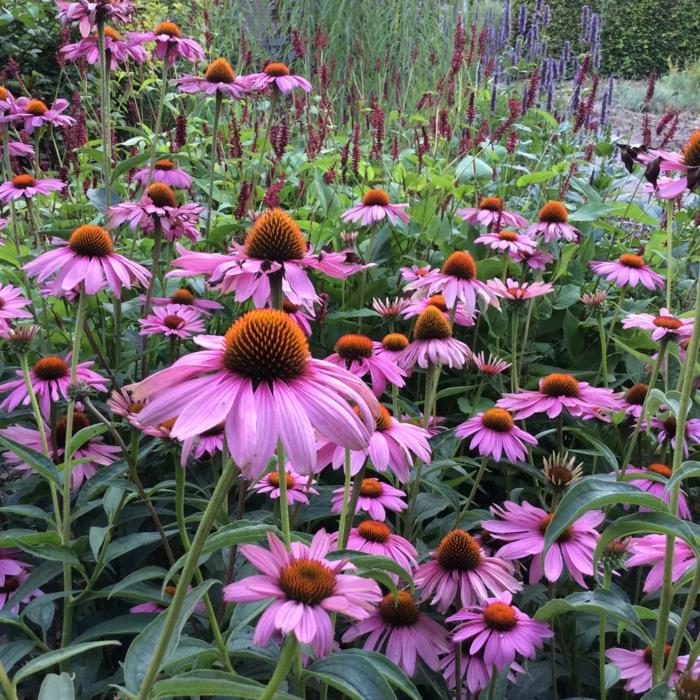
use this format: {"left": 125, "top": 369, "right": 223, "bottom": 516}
{"left": 544, "top": 476, "right": 668, "bottom": 552}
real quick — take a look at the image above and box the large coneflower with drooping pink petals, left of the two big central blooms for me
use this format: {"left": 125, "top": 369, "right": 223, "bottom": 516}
{"left": 24, "top": 224, "right": 150, "bottom": 297}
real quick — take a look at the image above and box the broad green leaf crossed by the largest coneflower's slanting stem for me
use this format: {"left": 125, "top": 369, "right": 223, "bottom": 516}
{"left": 124, "top": 581, "right": 214, "bottom": 692}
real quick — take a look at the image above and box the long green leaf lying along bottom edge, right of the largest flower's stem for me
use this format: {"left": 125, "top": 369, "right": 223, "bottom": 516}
{"left": 149, "top": 671, "right": 297, "bottom": 700}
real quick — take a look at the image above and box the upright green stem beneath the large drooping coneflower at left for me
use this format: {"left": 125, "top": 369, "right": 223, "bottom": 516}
{"left": 61, "top": 288, "right": 87, "bottom": 648}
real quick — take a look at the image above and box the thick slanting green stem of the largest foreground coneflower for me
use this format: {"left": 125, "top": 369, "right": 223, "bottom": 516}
{"left": 136, "top": 460, "right": 237, "bottom": 700}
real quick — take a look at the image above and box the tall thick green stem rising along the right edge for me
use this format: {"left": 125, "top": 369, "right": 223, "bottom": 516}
{"left": 647, "top": 278, "right": 700, "bottom": 683}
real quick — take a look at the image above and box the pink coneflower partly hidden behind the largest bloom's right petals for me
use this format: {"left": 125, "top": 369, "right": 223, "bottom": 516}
{"left": 317, "top": 405, "right": 430, "bottom": 481}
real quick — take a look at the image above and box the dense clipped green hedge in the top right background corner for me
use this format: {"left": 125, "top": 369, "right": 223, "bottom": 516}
{"left": 547, "top": 0, "right": 700, "bottom": 78}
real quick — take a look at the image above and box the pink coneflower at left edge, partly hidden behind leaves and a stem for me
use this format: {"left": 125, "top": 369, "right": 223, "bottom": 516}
{"left": 0, "top": 411, "right": 120, "bottom": 489}
